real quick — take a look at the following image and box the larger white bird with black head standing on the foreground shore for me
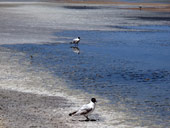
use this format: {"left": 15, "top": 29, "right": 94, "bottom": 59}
{"left": 69, "top": 98, "right": 97, "bottom": 120}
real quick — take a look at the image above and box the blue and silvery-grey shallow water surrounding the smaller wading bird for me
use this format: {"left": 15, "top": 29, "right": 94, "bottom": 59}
{"left": 0, "top": 2, "right": 170, "bottom": 128}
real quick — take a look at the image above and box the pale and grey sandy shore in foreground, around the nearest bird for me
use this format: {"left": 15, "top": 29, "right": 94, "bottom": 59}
{"left": 0, "top": 47, "right": 132, "bottom": 128}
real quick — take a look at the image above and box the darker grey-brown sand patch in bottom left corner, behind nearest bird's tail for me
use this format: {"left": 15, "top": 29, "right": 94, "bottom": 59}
{"left": 0, "top": 90, "right": 70, "bottom": 128}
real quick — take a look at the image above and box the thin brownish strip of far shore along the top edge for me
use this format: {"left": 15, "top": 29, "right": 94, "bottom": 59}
{"left": 0, "top": 0, "right": 170, "bottom": 12}
